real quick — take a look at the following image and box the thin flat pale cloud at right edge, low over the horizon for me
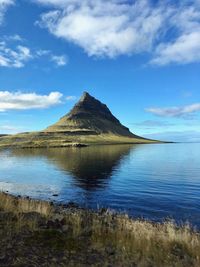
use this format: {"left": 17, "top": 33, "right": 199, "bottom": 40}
{"left": 146, "top": 103, "right": 200, "bottom": 118}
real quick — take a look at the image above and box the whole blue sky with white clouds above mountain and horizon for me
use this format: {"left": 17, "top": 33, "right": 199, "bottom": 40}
{"left": 0, "top": 0, "right": 200, "bottom": 142}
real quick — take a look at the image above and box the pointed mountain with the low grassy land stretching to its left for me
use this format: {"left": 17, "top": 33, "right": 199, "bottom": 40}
{"left": 0, "top": 92, "right": 159, "bottom": 147}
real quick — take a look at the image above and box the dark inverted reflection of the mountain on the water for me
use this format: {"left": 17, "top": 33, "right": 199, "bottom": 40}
{"left": 12, "top": 145, "right": 138, "bottom": 190}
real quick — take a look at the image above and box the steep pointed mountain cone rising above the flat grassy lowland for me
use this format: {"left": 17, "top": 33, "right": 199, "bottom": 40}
{"left": 45, "top": 92, "right": 139, "bottom": 137}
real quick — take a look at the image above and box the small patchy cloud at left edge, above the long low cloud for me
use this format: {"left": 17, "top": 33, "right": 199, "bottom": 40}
{"left": 0, "top": 42, "right": 32, "bottom": 68}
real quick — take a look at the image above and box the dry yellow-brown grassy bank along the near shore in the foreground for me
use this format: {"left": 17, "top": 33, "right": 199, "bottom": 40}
{"left": 0, "top": 193, "right": 200, "bottom": 267}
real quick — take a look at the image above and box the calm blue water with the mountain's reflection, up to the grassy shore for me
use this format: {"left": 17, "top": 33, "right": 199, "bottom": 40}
{"left": 0, "top": 144, "right": 200, "bottom": 228}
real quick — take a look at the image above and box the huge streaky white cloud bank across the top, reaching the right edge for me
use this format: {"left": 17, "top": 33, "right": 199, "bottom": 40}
{"left": 35, "top": 0, "right": 200, "bottom": 65}
